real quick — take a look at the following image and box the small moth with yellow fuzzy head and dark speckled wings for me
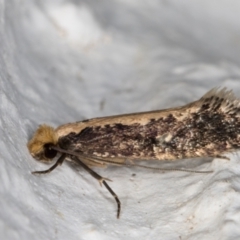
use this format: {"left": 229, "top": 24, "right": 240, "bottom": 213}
{"left": 27, "top": 88, "right": 240, "bottom": 218}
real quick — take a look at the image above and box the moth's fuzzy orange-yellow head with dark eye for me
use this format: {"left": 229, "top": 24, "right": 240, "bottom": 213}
{"left": 27, "top": 124, "right": 58, "bottom": 162}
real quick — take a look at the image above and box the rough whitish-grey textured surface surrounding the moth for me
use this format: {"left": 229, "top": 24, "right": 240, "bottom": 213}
{"left": 0, "top": 0, "right": 240, "bottom": 240}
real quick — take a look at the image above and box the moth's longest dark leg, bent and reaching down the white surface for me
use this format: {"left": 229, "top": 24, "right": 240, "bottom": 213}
{"left": 72, "top": 157, "right": 121, "bottom": 218}
